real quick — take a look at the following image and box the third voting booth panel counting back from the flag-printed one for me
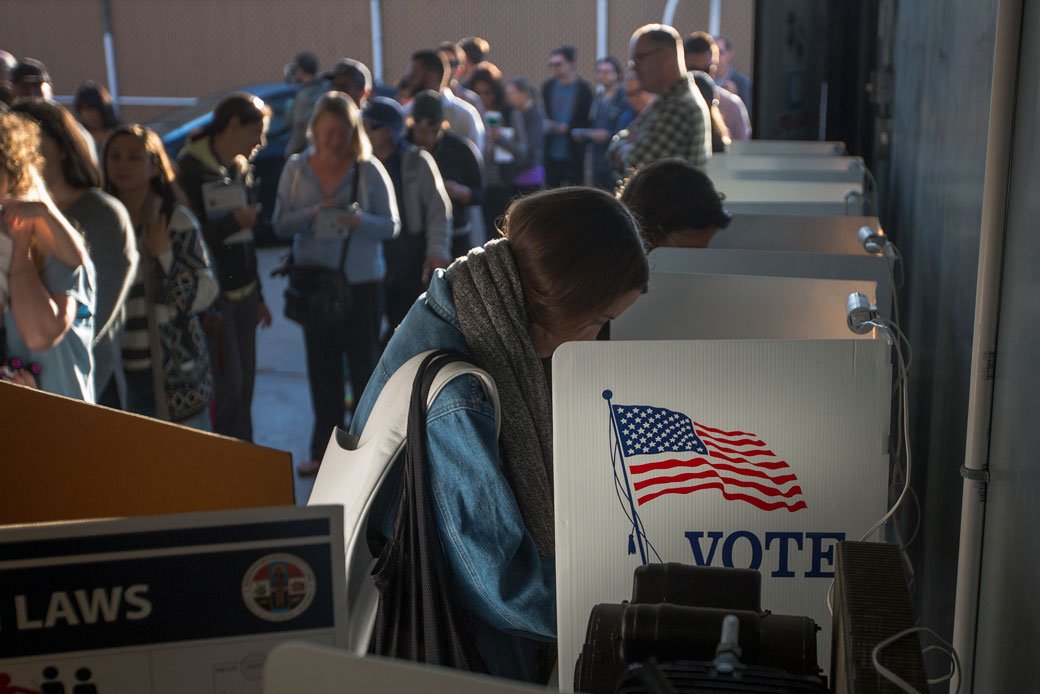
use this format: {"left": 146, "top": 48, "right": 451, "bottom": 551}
{"left": 650, "top": 248, "right": 892, "bottom": 316}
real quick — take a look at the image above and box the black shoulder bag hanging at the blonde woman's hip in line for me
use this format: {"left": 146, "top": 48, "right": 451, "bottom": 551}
{"left": 283, "top": 162, "right": 361, "bottom": 330}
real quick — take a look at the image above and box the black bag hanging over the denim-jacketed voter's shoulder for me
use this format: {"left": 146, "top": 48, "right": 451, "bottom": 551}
{"left": 371, "top": 350, "right": 497, "bottom": 672}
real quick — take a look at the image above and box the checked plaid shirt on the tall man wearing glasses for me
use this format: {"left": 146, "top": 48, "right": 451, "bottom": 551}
{"left": 625, "top": 73, "right": 711, "bottom": 173}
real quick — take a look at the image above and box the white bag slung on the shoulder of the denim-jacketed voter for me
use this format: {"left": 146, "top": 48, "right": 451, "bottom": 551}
{"left": 307, "top": 351, "right": 501, "bottom": 668}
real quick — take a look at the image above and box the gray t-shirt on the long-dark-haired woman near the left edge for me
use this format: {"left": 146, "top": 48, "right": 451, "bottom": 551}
{"left": 61, "top": 188, "right": 137, "bottom": 394}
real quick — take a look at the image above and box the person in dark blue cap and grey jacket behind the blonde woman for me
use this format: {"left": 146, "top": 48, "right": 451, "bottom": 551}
{"left": 355, "top": 97, "right": 453, "bottom": 339}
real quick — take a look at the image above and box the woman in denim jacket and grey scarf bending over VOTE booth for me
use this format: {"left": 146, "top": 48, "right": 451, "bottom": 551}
{"left": 350, "top": 188, "right": 649, "bottom": 682}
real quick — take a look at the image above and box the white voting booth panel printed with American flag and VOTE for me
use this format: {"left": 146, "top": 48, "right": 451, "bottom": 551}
{"left": 552, "top": 339, "right": 891, "bottom": 691}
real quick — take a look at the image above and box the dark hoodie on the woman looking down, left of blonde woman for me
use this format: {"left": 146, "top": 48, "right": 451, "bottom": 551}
{"left": 177, "top": 136, "right": 260, "bottom": 294}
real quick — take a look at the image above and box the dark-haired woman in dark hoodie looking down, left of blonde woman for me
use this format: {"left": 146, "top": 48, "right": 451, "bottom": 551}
{"left": 177, "top": 92, "right": 271, "bottom": 441}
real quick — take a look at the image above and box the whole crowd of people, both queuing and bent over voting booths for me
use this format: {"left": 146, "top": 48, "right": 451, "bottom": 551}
{"left": 0, "top": 25, "right": 751, "bottom": 679}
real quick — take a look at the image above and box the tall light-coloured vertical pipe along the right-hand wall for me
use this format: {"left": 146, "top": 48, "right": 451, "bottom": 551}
{"left": 951, "top": 0, "right": 1022, "bottom": 694}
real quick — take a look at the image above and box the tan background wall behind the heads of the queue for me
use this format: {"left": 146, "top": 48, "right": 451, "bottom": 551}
{"left": 0, "top": 0, "right": 754, "bottom": 120}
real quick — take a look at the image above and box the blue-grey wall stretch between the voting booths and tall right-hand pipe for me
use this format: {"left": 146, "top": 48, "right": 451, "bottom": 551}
{"left": 883, "top": 0, "right": 1002, "bottom": 657}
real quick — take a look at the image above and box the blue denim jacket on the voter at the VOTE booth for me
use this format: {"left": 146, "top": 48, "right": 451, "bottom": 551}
{"left": 350, "top": 271, "right": 556, "bottom": 680}
